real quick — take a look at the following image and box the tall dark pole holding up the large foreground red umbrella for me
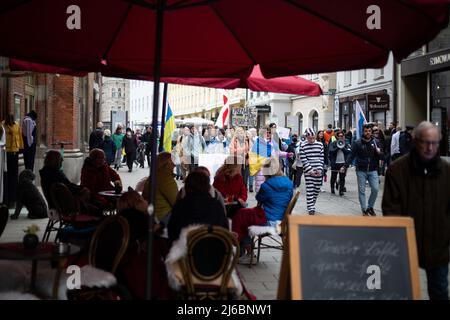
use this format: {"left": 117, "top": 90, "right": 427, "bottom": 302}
{"left": 145, "top": 0, "right": 166, "bottom": 300}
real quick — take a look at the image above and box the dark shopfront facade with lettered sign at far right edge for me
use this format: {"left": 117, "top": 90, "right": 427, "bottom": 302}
{"left": 397, "top": 10, "right": 450, "bottom": 157}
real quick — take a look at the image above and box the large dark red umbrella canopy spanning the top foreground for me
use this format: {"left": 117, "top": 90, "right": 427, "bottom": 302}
{"left": 0, "top": 0, "right": 448, "bottom": 78}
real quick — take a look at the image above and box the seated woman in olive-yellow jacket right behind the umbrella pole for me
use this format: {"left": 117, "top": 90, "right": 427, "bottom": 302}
{"left": 142, "top": 152, "right": 178, "bottom": 226}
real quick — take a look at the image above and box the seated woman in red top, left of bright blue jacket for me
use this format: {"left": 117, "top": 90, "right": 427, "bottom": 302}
{"left": 213, "top": 156, "right": 247, "bottom": 214}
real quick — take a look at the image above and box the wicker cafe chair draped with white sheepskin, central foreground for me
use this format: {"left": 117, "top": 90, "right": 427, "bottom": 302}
{"left": 166, "top": 226, "right": 242, "bottom": 300}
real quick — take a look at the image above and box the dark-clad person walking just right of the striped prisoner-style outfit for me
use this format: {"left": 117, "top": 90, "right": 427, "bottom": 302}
{"left": 328, "top": 131, "right": 352, "bottom": 196}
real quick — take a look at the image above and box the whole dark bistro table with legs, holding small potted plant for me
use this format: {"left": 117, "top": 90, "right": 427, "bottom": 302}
{"left": 0, "top": 242, "right": 81, "bottom": 299}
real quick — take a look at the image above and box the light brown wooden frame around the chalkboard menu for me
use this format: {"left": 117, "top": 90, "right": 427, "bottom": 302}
{"left": 289, "top": 216, "right": 420, "bottom": 300}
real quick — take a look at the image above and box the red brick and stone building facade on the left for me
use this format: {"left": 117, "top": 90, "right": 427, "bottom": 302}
{"left": 0, "top": 58, "right": 101, "bottom": 183}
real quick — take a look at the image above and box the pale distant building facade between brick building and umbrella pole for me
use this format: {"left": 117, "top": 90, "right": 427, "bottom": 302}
{"left": 100, "top": 77, "right": 130, "bottom": 131}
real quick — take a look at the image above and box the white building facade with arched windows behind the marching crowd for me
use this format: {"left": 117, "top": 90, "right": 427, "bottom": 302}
{"left": 290, "top": 73, "right": 336, "bottom": 134}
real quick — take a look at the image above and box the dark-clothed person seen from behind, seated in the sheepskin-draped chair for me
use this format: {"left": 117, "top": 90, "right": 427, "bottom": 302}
{"left": 167, "top": 171, "right": 229, "bottom": 243}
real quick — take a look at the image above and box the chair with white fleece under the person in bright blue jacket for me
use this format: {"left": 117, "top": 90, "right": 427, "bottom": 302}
{"left": 248, "top": 191, "right": 300, "bottom": 268}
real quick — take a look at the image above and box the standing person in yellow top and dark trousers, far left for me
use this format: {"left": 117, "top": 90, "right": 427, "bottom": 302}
{"left": 3, "top": 114, "right": 23, "bottom": 208}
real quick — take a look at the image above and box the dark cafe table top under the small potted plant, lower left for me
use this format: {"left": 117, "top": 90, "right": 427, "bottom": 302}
{"left": 0, "top": 242, "right": 81, "bottom": 260}
